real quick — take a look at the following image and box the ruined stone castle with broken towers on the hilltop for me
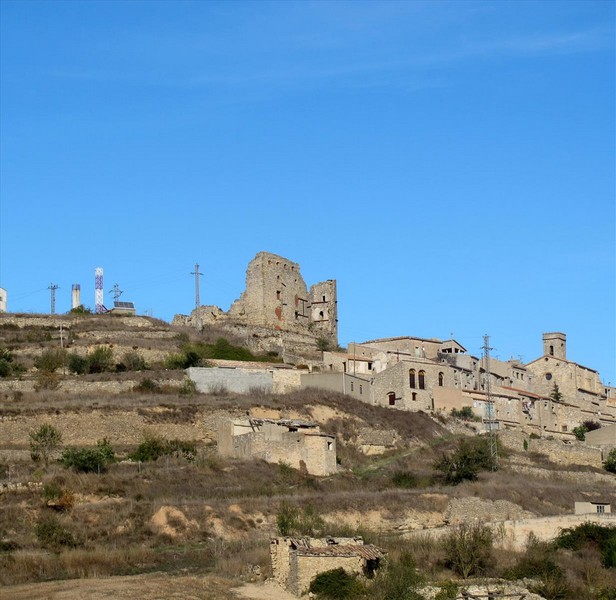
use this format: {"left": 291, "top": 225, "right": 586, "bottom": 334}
{"left": 173, "top": 252, "right": 338, "bottom": 354}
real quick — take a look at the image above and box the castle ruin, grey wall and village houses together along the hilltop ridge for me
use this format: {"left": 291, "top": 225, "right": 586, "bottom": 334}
{"left": 173, "top": 252, "right": 616, "bottom": 440}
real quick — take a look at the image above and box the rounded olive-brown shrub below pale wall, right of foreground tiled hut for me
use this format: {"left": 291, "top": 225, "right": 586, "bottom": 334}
{"left": 443, "top": 523, "right": 495, "bottom": 579}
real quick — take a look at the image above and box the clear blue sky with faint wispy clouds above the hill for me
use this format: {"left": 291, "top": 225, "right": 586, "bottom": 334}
{"left": 0, "top": 0, "right": 616, "bottom": 385}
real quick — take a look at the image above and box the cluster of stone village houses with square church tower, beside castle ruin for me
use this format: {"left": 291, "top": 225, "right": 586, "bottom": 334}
{"left": 301, "top": 333, "right": 616, "bottom": 438}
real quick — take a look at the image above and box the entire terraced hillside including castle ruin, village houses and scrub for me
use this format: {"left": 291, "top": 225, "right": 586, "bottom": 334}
{"left": 0, "top": 252, "right": 616, "bottom": 600}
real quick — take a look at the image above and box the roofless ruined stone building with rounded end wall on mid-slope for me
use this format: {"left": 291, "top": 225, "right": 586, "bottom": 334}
{"left": 217, "top": 419, "right": 338, "bottom": 476}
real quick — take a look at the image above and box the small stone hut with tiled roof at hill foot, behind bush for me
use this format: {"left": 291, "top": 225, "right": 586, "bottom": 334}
{"left": 270, "top": 537, "right": 385, "bottom": 596}
